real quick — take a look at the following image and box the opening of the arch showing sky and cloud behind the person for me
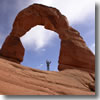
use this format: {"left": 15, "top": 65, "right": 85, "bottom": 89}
{"left": 21, "top": 25, "right": 60, "bottom": 71}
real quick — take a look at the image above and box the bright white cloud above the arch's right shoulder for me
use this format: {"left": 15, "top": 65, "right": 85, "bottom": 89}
{"left": 56, "top": 0, "right": 95, "bottom": 24}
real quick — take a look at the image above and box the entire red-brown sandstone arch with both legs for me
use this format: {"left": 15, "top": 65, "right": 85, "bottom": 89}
{"left": 0, "top": 4, "right": 95, "bottom": 72}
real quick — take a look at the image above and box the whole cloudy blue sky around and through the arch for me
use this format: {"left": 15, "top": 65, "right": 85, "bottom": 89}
{"left": 0, "top": 0, "right": 95, "bottom": 71}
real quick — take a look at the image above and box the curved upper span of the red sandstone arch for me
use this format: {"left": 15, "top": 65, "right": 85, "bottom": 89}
{"left": 11, "top": 4, "right": 69, "bottom": 37}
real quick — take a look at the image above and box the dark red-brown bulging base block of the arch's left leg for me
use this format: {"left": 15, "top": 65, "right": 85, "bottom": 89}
{"left": 0, "top": 36, "right": 24, "bottom": 63}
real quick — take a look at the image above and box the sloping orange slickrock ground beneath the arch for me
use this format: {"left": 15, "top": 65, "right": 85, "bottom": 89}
{"left": 0, "top": 58, "right": 95, "bottom": 95}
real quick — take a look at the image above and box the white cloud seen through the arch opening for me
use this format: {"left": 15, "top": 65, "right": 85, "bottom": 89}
{"left": 21, "top": 26, "right": 57, "bottom": 51}
